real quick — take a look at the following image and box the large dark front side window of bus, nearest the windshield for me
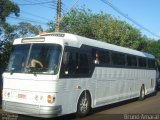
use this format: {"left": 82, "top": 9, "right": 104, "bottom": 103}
{"left": 61, "top": 51, "right": 90, "bottom": 76}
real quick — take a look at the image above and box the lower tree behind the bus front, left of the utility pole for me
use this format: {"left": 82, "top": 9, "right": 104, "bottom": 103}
{"left": 0, "top": 22, "right": 43, "bottom": 68}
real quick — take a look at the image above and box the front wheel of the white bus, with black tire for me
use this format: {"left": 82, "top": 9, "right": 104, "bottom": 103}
{"left": 77, "top": 92, "right": 91, "bottom": 117}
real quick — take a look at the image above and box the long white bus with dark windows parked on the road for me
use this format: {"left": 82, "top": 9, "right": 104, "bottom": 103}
{"left": 2, "top": 33, "right": 156, "bottom": 117}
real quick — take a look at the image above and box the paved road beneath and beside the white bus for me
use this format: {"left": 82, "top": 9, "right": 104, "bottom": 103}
{"left": 0, "top": 92, "right": 160, "bottom": 120}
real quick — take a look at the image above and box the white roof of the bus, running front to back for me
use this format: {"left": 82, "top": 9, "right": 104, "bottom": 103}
{"left": 14, "top": 33, "right": 155, "bottom": 59}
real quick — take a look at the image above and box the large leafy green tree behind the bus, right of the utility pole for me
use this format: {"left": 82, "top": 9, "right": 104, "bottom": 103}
{"left": 48, "top": 9, "right": 144, "bottom": 49}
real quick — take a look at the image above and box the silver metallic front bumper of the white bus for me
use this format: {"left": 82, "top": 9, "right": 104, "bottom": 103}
{"left": 2, "top": 100, "right": 62, "bottom": 118}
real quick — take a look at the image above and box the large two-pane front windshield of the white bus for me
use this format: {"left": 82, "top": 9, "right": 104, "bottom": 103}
{"left": 6, "top": 43, "right": 61, "bottom": 74}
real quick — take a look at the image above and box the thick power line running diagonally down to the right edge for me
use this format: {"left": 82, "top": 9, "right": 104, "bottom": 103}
{"left": 101, "top": 0, "right": 160, "bottom": 38}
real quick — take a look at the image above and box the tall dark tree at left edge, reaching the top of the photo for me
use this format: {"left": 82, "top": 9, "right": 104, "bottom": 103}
{"left": 0, "top": 0, "right": 20, "bottom": 68}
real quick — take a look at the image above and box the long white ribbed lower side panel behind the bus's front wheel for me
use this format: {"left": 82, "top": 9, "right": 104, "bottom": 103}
{"left": 92, "top": 67, "right": 155, "bottom": 107}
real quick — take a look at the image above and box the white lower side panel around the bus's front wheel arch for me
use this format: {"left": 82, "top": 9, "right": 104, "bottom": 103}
{"left": 57, "top": 78, "right": 96, "bottom": 114}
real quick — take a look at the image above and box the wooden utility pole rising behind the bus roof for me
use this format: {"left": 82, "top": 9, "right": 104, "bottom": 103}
{"left": 55, "top": 0, "right": 61, "bottom": 32}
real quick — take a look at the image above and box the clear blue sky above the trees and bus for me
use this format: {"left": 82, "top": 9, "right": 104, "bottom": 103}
{"left": 7, "top": 0, "right": 160, "bottom": 40}
